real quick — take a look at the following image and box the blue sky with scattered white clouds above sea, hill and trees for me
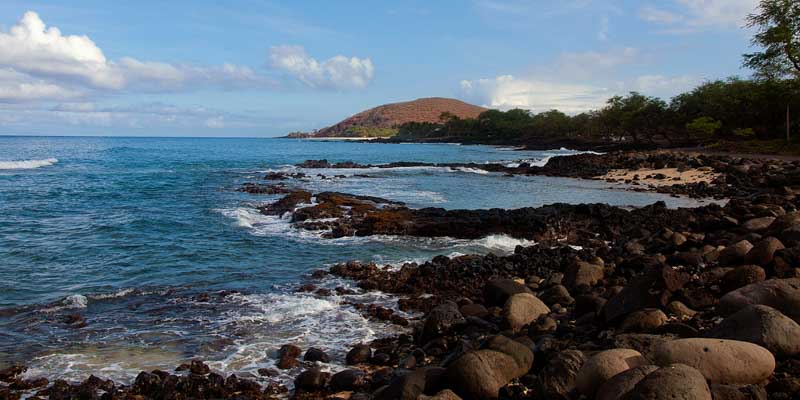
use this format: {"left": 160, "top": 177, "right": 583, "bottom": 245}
{"left": 0, "top": 0, "right": 758, "bottom": 137}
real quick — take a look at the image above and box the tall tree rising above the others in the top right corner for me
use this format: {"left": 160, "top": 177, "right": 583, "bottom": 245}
{"left": 744, "top": 0, "right": 800, "bottom": 142}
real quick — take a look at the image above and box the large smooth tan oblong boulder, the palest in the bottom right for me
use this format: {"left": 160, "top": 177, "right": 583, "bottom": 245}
{"left": 653, "top": 338, "right": 775, "bottom": 385}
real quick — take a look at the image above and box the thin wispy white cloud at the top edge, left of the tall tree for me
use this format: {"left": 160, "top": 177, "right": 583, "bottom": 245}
{"left": 639, "top": 0, "right": 759, "bottom": 33}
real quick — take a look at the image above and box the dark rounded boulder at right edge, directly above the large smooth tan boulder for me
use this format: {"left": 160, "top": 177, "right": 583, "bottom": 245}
{"left": 707, "top": 305, "right": 800, "bottom": 358}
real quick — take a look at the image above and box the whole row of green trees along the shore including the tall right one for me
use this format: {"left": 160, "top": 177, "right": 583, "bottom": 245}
{"left": 396, "top": 0, "right": 800, "bottom": 144}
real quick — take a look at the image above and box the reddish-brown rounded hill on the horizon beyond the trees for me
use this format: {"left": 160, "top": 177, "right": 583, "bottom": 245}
{"left": 315, "top": 97, "right": 486, "bottom": 137}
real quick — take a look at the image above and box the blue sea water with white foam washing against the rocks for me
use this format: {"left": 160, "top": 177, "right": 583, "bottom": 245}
{"left": 0, "top": 137, "right": 708, "bottom": 380}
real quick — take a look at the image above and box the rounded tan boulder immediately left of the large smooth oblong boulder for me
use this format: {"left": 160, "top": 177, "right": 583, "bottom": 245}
{"left": 575, "top": 349, "right": 649, "bottom": 396}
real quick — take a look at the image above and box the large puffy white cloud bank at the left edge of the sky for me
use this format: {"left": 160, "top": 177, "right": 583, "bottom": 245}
{"left": 0, "top": 11, "right": 274, "bottom": 99}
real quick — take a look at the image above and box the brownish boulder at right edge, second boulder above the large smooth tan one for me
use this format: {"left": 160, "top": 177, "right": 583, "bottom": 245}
{"left": 718, "top": 278, "right": 800, "bottom": 323}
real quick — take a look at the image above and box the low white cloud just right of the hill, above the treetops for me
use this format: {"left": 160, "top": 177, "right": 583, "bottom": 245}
{"left": 461, "top": 75, "right": 609, "bottom": 113}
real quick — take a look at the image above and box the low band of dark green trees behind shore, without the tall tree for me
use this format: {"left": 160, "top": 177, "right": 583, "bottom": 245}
{"left": 397, "top": 78, "right": 800, "bottom": 145}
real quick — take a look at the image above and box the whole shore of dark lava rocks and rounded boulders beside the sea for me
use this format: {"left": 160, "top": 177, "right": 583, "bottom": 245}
{"left": 0, "top": 152, "right": 800, "bottom": 400}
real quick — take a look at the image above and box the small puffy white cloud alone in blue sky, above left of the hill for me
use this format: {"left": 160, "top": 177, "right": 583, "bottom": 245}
{"left": 269, "top": 46, "right": 375, "bottom": 89}
